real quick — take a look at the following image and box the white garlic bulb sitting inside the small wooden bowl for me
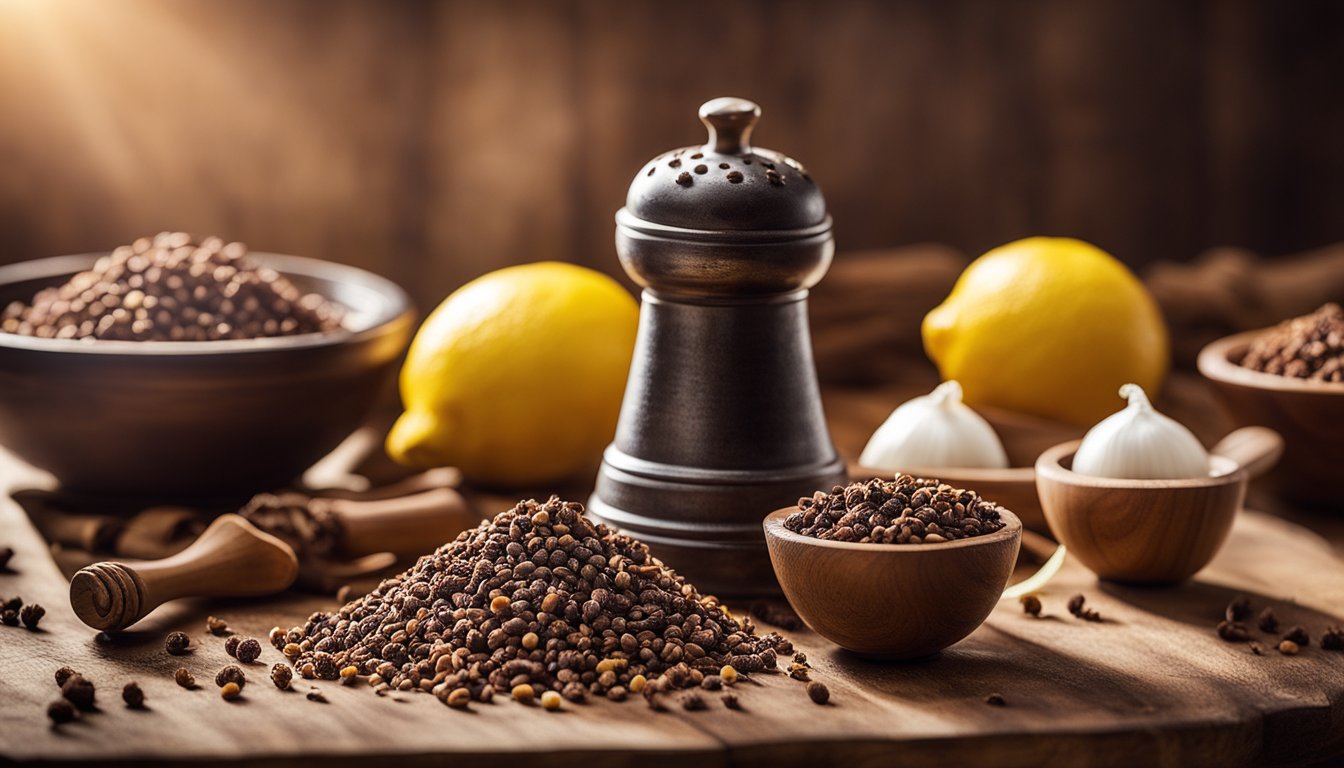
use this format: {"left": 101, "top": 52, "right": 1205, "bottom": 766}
{"left": 1073, "top": 383, "right": 1208, "bottom": 480}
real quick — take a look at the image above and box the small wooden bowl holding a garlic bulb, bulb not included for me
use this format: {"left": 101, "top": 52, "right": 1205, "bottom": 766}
{"left": 1036, "top": 440, "right": 1247, "bottom": 584}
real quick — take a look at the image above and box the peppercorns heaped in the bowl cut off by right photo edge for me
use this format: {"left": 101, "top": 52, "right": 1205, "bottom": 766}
{"left": 1241, "top": 304, "right": 1344, "bottom": 382}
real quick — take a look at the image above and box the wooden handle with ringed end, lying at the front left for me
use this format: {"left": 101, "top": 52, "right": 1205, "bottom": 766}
{"left": 70, "top": 515, "right": 298, "bottom": 631}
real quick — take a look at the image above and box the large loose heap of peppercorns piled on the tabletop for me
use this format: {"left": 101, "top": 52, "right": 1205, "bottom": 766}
{"left": 283, "top": 496, "right": 793, "bottom": 706}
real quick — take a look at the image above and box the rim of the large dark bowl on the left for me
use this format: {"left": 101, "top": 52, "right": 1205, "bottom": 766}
{"left": 0, "top": 250, "right": 415, "bottom": 356}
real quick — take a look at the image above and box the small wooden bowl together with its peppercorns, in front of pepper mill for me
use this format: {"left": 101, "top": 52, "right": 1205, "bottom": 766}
{"left": 765, "top": 476, "right": 1021, "bottom": 659}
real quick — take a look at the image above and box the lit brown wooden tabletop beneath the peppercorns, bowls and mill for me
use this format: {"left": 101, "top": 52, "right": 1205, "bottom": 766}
{"left": 0, "top": 393, "right": 1344, "bottom": 767}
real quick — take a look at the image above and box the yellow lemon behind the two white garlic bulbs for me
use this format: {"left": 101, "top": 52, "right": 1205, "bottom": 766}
{"left": 923, "top": 237, "right": 1168, "bottom": 426}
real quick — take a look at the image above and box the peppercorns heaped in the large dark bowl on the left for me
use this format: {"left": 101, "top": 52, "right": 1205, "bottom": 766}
{"left": 0, "top": 233, "right": 341, "bottom": 342}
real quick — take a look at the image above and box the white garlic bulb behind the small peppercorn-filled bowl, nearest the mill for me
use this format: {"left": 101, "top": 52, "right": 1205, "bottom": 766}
{"left": 859, "top": 381, "right": 1008, "bottom": 472}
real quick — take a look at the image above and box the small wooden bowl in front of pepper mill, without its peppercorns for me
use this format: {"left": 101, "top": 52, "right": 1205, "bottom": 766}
{"left": 765, "top": 507, "right": 1021, "bottom": 659}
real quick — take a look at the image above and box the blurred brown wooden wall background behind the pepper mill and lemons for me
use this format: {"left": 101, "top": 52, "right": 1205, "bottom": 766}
{"left": 0, "top": 0, "right": 1344, "bottom": 318}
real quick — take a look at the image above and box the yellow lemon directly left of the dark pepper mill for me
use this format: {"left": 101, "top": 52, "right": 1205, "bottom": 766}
{"left": 387, "top": 262, "right": 638, "bottom": 486}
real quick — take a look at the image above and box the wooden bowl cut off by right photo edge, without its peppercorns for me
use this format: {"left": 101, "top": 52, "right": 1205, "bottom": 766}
{"left": 1198, "top": 330, "right": 1344, "bottom": 510}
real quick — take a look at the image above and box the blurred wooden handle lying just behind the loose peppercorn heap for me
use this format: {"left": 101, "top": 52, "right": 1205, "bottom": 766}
{"left": 329, "top": 488, "right": 480, "bottom": 557}
